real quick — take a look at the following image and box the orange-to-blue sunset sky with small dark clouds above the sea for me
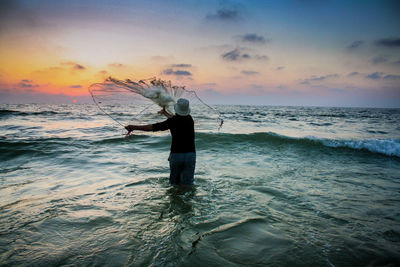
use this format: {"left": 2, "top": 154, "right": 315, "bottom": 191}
{"left": 0, "top": 0, "right": 400, "bottom": 108}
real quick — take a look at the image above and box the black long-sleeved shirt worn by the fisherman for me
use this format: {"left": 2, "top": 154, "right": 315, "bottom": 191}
{"left": 153, "top": 115, "right": 196, "bottom": 153}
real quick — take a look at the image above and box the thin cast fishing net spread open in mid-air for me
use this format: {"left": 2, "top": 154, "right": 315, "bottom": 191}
{"left": 89, "top": 77, "right": 223, "bottom": 131}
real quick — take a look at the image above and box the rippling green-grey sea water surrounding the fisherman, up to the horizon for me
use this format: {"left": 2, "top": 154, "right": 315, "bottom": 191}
{"left": 0, "top": 105, "right": 400, "bottom": 266}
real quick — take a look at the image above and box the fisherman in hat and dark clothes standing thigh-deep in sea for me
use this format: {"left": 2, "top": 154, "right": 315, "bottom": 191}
{"left": 125, "top": 98, "right": 196, "bottom": 185}
